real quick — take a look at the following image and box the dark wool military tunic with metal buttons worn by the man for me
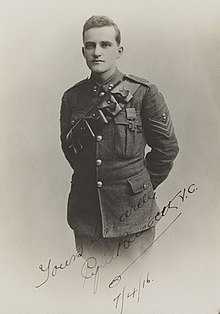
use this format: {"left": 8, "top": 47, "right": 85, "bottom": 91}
{"left": 60, "top": 70, "right": 178, "bottom": 238}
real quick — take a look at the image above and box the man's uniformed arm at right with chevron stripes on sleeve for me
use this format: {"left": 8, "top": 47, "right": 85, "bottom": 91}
{"left": 142, "top": 85, "right": 179, "bottom": 189}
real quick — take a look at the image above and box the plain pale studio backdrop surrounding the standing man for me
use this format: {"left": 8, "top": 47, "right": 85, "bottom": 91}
{"left": 0, "top": 0, "right": 220, "bottom": 314}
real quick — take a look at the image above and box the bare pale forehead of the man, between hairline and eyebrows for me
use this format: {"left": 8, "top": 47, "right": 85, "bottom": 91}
{"left": 83, "top": 26, "right": 116, "bottom": 43}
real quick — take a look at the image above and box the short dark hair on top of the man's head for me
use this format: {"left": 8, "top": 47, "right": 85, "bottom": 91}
{"left": 83, "top": 15, "right": 121, "bottom": 45}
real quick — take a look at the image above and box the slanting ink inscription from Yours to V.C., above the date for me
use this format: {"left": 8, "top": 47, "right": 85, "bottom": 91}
{"left": 36, "top": 183, "right": 198, "bottom": 293}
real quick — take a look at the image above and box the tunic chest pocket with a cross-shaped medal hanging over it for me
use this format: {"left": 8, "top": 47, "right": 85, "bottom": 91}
{"left": 114, "top": 108, "right": 145, "bottom": 158}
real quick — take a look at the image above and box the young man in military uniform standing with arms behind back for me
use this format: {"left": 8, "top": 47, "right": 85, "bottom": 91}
{"left": 60, "top": 16, "right": 178, "bottom": 262}
